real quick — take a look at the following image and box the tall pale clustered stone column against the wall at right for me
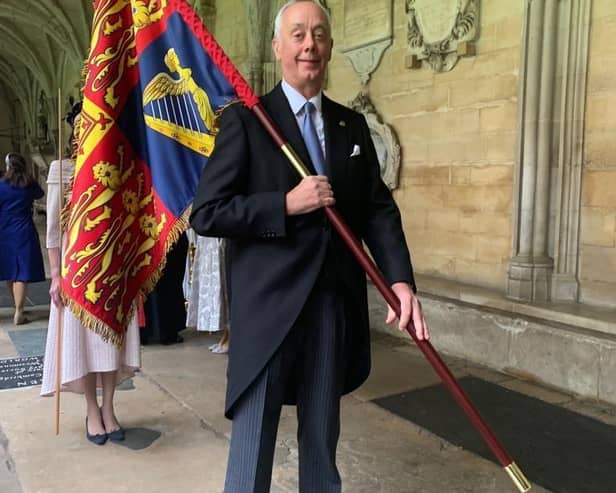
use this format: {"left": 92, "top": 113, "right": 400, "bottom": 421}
{"left": 507, "top": 0, "right": 591, "bottom": 301}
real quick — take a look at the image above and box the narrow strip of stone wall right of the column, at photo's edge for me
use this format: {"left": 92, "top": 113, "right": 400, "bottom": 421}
{"left": 580, "top": 0, "right": 616, "bottom": 306}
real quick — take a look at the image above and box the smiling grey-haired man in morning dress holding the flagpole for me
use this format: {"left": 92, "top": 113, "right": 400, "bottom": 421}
{"left": 191, "top": 0, "right": 428, "bottom": 493}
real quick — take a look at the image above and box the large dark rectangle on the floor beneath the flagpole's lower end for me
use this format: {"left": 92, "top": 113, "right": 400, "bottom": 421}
{"left": 374, "top": 377, "right": 616, "bottom": 493}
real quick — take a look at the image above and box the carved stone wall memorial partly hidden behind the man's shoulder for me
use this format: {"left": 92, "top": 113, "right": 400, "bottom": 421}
{"left": 349, "top": 92, "right": 400, "bottom": 190}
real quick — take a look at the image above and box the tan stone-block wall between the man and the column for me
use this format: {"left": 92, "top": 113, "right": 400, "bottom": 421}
{"left": 318, "top": 0, "right": 523, "bottom": 289}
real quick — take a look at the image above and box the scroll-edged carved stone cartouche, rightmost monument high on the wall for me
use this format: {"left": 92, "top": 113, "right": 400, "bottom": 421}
{"left": 405, "top": 0, "right": 479, "bottom": 72}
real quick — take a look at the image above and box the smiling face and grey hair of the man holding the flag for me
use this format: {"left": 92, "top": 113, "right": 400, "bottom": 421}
{"left": 272, "top": 2, "right": 333, "bottom": 98}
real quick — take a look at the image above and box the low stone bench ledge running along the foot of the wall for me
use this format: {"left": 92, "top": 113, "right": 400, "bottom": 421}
{"left": 369, "top": 277, "right": 616, "bottom": 404}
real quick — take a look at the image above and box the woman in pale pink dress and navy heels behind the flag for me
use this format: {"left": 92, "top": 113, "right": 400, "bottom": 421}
{"left": 41, "top": 106, "right": 141, "bottom": 445}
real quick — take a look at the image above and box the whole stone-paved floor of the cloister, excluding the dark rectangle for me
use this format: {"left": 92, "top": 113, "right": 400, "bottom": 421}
{"left": 0, "top": 286, "right": 616, "bottom": 493}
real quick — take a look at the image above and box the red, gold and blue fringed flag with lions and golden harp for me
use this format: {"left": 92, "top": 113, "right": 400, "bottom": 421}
{"left": 62, "top": 0, "right": 251, "bottom": 345}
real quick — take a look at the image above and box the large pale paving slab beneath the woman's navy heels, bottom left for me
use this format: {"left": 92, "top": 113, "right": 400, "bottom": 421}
{"left": 0, "top": 377, "right": 228, "bottom": 493}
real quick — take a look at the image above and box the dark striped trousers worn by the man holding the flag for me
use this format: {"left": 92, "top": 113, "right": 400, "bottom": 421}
{"left": 224, "top": 288, "right": 344, "bottom": 493}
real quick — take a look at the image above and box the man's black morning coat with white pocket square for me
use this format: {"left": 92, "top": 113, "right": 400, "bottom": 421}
{"left": 190, "top": 84, "right": 415, "bottom": 418}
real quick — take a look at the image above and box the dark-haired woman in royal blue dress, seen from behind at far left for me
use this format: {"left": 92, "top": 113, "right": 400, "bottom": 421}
{"left": 0, "top": 152, "right": 45, "bottom": 325}
